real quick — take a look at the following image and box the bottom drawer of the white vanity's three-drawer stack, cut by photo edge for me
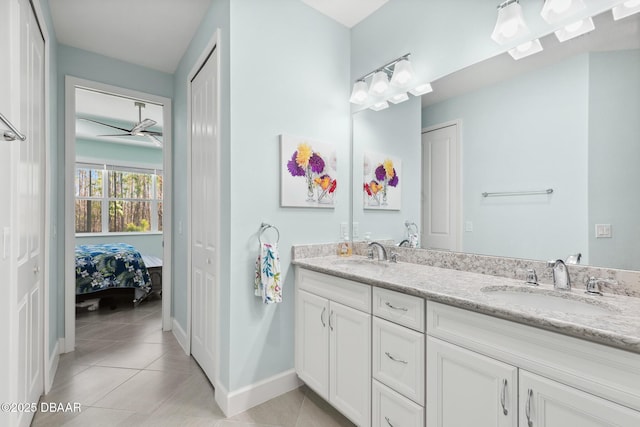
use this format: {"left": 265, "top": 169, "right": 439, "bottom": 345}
{"left": 371, "top": 380, "right": 424, "bottom": 427}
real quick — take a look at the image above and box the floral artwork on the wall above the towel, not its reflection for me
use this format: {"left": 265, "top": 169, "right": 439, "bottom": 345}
{"left": 280, "top": 134, "right": 338, "bottom": 208}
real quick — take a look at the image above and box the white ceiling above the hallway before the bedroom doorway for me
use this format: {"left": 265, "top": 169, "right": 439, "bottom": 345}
{"left": 49, "top": 0, "right": 211, "bottom": 74}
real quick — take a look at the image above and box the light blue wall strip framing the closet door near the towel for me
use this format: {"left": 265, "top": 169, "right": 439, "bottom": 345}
{"left": 172, "top": 0, "right": 232, "bottom": 386}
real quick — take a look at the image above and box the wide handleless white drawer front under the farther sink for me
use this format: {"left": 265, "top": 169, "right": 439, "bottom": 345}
{"left": 296, "top": 268, "right": 371, "bottom": 313}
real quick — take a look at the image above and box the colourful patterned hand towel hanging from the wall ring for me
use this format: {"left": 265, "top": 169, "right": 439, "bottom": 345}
{"left": 254, "top": 243, "right": 282, "bottom": 304}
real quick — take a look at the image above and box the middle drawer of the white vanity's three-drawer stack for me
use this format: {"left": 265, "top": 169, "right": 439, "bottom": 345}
{"left": 372, "top": 317, "right": 425, "bottom": 405}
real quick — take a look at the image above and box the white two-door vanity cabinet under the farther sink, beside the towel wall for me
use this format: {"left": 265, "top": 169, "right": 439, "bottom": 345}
{"left": 295, "top": 269, "right": 371, "bottom": 427}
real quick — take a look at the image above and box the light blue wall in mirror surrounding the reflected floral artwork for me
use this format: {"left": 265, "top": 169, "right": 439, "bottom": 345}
{"left": 353, "top": 97, "right": 421, "bottom": 242}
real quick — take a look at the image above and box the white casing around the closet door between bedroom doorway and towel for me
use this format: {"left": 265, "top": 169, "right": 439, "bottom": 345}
{"left": 186, "top": 29, "right": 222, "bottom": 372}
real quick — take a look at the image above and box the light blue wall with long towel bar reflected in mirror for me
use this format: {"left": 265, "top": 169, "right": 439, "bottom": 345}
{"left": 422, "top": 55, "right": 589, "bottom": 259}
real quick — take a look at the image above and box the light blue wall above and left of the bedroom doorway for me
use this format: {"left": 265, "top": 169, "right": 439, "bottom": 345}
{"left": 51, "top": 43, "right": 173, "bottom": 346}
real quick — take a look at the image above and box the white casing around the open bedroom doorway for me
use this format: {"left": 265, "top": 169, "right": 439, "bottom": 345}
{"left": 64, "top": 75, "right": 173, "bottom": 352}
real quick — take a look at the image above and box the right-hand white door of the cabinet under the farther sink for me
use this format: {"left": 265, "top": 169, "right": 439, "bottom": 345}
{"left": 329, "top": 301, "right": 371, "bottom": 426}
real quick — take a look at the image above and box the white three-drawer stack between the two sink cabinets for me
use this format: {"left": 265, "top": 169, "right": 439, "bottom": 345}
{"left": 371, "top": 287, "right": 425, "bottom": 427}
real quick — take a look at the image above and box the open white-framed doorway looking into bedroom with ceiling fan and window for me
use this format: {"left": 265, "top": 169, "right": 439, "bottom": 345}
{"left": 62, "top": 76, "right": 172, "bottom": 352}
